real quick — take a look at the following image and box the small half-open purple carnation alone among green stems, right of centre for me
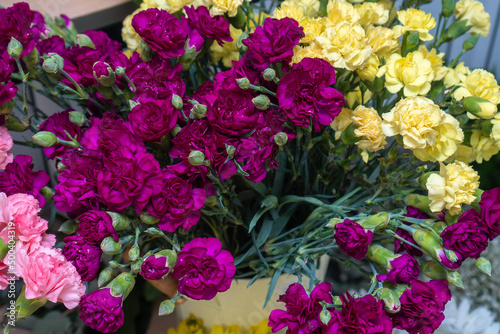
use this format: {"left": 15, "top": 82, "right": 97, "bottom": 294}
{"left": 335, "top": 219, "right": 373, "bottom": 260}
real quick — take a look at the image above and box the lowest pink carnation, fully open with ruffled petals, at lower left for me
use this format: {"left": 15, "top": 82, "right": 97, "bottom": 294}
{"left": 16, "top": 247, "right": 85, "bottom": 309}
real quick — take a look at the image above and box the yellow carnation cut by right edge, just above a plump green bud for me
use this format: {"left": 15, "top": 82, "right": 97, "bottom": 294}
{"left": 453, "top": 68, "right": 500, "bottom": 104}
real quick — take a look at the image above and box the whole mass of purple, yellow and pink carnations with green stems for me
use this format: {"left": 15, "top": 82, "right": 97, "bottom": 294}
{"left": 0, "top": 0, "right": 500, "bottom": 334}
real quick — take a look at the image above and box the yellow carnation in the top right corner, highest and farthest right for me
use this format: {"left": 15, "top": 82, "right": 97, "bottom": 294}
{"left": 455, "top": 0, "right": 491, "bottom": 37}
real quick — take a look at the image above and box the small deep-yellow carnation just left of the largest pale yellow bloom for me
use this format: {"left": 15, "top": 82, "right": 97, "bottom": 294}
{"left": 352, "top": 105, "right": 387, "bottom": 162}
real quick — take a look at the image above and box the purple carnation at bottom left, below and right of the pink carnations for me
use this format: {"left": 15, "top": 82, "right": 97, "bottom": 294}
{"left": 78, "top": 288, "right": 125, "bottom": 333}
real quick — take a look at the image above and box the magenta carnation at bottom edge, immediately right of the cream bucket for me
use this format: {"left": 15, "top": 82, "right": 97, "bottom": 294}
{"left": 269, "top": 282, "right": 333, "bottom": 334}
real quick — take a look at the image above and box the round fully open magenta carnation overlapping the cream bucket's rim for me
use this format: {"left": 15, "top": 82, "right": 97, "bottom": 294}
{"left": 172, "top": 238, "right": 236, "bottom": 300}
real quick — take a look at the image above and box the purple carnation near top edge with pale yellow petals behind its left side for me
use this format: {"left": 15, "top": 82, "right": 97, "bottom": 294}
{"left": 132, "top": 8, "right": 189, "bottom": 58}
